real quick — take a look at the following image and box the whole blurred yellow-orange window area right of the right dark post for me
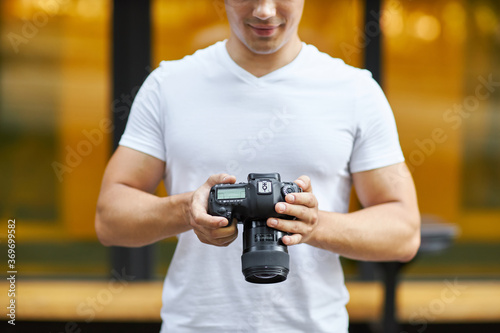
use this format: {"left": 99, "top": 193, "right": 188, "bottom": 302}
{"left": 382, "top": 0, "right": 500, "bottom": 241}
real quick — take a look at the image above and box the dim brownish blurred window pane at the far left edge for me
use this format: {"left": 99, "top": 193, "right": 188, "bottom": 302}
{"left": 0, "top": 1, "right": 62, "bottom": 224}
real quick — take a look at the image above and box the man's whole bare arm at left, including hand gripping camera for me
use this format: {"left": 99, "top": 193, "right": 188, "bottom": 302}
{"left": 95, "top": 147, "right": 238, "bottom": 247}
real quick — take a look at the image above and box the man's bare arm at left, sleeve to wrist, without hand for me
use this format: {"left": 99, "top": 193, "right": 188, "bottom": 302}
{"left": 95, "top": 146, "right": 192, "bottom": 247}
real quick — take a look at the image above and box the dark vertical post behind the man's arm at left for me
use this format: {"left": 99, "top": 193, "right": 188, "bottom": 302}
{"left": 111, "top": 0, "right": 154, "bottom": 281}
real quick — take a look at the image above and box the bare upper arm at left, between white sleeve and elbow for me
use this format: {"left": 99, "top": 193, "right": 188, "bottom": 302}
{"left": 102, "top": 146, "right": 165, "bottom": 193}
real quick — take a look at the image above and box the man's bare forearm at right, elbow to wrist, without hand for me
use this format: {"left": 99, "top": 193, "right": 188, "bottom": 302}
{"left": 308, "top": 202, "right": 420, "bottom": 261}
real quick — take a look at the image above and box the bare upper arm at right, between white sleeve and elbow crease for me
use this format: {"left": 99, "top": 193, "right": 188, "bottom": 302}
{"left": 352, "top": 162, "right": 418, "bottom": 209}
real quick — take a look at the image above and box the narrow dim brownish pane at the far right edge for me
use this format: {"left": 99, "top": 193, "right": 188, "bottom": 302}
{"left": 463, "top": 0, "right": 500, "bottom": 210}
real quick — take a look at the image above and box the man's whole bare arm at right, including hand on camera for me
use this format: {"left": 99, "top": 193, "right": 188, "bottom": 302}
{"left": 268, "top": 163, "right": 420, "bottom": 261}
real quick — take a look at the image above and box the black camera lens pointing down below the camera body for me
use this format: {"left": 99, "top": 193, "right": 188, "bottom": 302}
{"left": 241, "top": 220, "right": 290, "bottom": 283}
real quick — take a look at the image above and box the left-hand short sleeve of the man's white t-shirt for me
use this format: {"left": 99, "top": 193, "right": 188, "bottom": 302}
{"left": 119, "top": 67, "right": 166, "bottom": 161}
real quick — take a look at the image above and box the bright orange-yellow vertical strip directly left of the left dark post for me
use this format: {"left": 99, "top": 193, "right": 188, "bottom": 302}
{"left": 59, "top": 7, "right": 112, "bottom": 238}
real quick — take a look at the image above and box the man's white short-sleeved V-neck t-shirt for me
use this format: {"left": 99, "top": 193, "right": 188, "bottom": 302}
{"left": 120, "top": 41, "right": 404, "bottom": 333}
